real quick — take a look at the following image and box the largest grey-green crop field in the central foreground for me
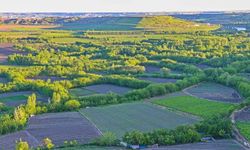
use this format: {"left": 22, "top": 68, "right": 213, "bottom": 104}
{"left": 80, "top": 103, "right": 196, "bottom": 137}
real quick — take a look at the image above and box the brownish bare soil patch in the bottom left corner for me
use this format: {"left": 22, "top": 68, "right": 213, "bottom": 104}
{"left": 0, "top": 131, "right": 41, "bottom": 150}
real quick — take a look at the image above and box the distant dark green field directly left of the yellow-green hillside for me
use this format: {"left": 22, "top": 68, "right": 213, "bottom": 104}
{"left": 58, "top": 17, "right": 141, "bottom": 31}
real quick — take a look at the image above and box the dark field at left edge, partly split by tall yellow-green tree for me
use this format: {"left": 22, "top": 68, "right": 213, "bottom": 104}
{"left": 0, "top": 91, "right": 48, "bottom": 107}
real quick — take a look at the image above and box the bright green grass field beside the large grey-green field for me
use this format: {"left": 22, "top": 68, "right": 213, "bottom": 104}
{"left": 154, "top": 96, "right": 235, "bottom": 118}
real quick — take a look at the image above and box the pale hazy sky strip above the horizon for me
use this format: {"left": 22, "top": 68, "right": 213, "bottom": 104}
{"left": 0, "top": 0, "right": 250, "bottom": 12}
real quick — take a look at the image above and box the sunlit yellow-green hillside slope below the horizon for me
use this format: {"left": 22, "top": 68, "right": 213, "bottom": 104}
{"left": 137, "top": 16, "right": 219, "bottom": 32}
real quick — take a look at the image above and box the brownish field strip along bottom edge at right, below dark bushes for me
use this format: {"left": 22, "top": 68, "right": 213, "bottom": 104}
{"left": 147, "top": 140, "right": 245, "bottom": 150}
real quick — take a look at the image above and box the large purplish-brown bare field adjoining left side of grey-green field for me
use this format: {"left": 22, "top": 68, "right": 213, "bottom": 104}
{"left": 27, "top": 112, "right": 101, "bottom": 145}
